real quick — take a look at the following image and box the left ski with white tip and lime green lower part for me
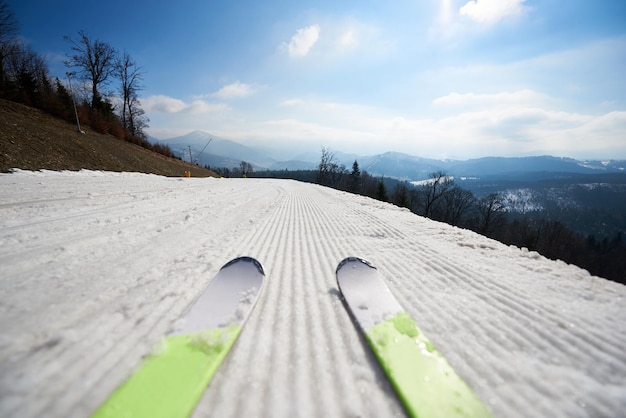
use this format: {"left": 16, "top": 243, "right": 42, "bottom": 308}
{"left": 92, "top": 257, "right": 265, "bottom": 418}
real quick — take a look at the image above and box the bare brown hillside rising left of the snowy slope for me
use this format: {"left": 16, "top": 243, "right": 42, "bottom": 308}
{"left": 0, "top": 99, "right": 215, "bottom": 177}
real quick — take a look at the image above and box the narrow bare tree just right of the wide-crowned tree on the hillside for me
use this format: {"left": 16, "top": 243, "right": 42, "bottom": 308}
{"left": 115, "top": 52, "right": 147, "bottom": 136}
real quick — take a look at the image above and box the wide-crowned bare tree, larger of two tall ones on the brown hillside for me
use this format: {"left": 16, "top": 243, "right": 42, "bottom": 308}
{"left": 64, "top": 30, "right": 117, "bottom": 109}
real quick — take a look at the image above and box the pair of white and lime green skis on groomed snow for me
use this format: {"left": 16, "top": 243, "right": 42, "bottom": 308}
{"left": 93, "top": 257, "right": 490, "bottom": 418}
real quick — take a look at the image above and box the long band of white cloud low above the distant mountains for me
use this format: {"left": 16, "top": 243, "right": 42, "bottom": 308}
{"left": 142, "top": 76, "right": 626, "bottom": 159}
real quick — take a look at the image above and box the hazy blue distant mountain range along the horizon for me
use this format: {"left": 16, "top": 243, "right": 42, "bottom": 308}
{"left": 150, "top": 131, "right": 626, "bottom": 181}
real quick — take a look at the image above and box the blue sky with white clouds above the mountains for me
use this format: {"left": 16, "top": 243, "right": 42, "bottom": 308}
{"left": 7, "top": 0, "right": 626, "bottom": 159}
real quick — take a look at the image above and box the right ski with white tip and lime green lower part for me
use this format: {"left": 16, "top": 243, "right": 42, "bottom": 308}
{"left": 336, "top": 257, "right": 491, "bottom": 418}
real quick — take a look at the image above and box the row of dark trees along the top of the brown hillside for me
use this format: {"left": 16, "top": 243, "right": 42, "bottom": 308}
{"left": 0, "top": 0, "right": 173, "bottom": 157}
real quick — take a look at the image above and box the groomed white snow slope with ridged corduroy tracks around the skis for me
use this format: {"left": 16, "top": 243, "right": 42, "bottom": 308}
{"left": 0, "top": 171, "right": 626, "bottom": 417}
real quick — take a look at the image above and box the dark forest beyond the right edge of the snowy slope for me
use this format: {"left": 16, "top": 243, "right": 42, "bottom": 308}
{"left": 239, "top": 148, "right": 626, "bottom": 284}
